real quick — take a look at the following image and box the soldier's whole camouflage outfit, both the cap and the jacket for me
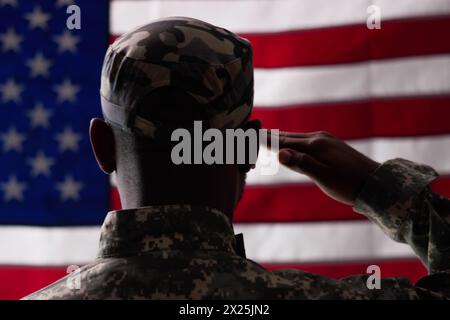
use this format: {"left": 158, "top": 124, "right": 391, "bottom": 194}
{"left": 22, "top": 17, "right": 450, "bottom": 299}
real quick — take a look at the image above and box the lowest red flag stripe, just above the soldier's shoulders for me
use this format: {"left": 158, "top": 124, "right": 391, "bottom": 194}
{"left": 0, "top": 260, "right": 426, "bottom": 300}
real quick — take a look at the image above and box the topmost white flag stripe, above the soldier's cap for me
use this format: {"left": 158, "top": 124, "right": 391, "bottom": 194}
{"left": 110, "top": 0, "right": 450, "bottom": 35}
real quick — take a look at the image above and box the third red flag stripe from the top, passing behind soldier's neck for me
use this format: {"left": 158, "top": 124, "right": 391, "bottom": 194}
{"left": 111, "top": 176, "right": 450, "bottom": 223}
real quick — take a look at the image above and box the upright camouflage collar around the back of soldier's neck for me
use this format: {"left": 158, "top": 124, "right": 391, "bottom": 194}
{"left": 98, "top": 205, "right": 245, "bottom": 258}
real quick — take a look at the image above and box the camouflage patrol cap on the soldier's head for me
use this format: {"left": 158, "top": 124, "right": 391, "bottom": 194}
{"left": 100, "top": 17, "right": 253, "bottom": 138}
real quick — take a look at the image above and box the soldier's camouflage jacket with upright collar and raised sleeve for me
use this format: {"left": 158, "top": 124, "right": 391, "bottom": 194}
{"left": 25, "top": 159, "right": 450, "bottom": 299}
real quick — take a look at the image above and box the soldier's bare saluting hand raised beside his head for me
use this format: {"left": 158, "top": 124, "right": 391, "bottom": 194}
{"left": 269, "top": 132, "right": 379, "bottom": 205}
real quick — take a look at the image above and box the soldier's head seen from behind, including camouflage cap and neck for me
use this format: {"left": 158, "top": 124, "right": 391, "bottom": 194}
{"left": 90, "top": 17, "right": 260, "bottom": 220}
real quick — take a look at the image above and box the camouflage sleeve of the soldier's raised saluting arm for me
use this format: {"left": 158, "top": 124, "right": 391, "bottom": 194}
{"left": 354, "top": 159, "right": 450, "bottom": 273}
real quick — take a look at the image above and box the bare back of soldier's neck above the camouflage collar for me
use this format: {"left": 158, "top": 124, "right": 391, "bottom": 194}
{"left": 117, "top": 165, "right": 245, "bottom": 218}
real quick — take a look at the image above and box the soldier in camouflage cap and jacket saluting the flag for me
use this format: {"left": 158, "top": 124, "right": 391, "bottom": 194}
{"left": 25, "top": 17, "right": 450, "bottom": 299}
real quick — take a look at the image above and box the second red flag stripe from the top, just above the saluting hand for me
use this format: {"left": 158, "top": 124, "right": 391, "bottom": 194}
{"left": 252, "top": 96, "right": 450, "bottom": 139}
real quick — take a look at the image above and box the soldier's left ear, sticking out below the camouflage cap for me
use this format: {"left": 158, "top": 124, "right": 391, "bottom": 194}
{"left": 89, "top": 118, "right": 116, "bottom": 174}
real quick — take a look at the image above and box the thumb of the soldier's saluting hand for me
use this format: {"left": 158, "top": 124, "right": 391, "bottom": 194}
{"left": 278, "top": 149, "right": 327, "bottom": 180}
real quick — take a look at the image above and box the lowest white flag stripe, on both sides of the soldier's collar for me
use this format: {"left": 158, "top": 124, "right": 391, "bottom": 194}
{"left": 0, "top": 221, "right": 413, "bottom": 266}
